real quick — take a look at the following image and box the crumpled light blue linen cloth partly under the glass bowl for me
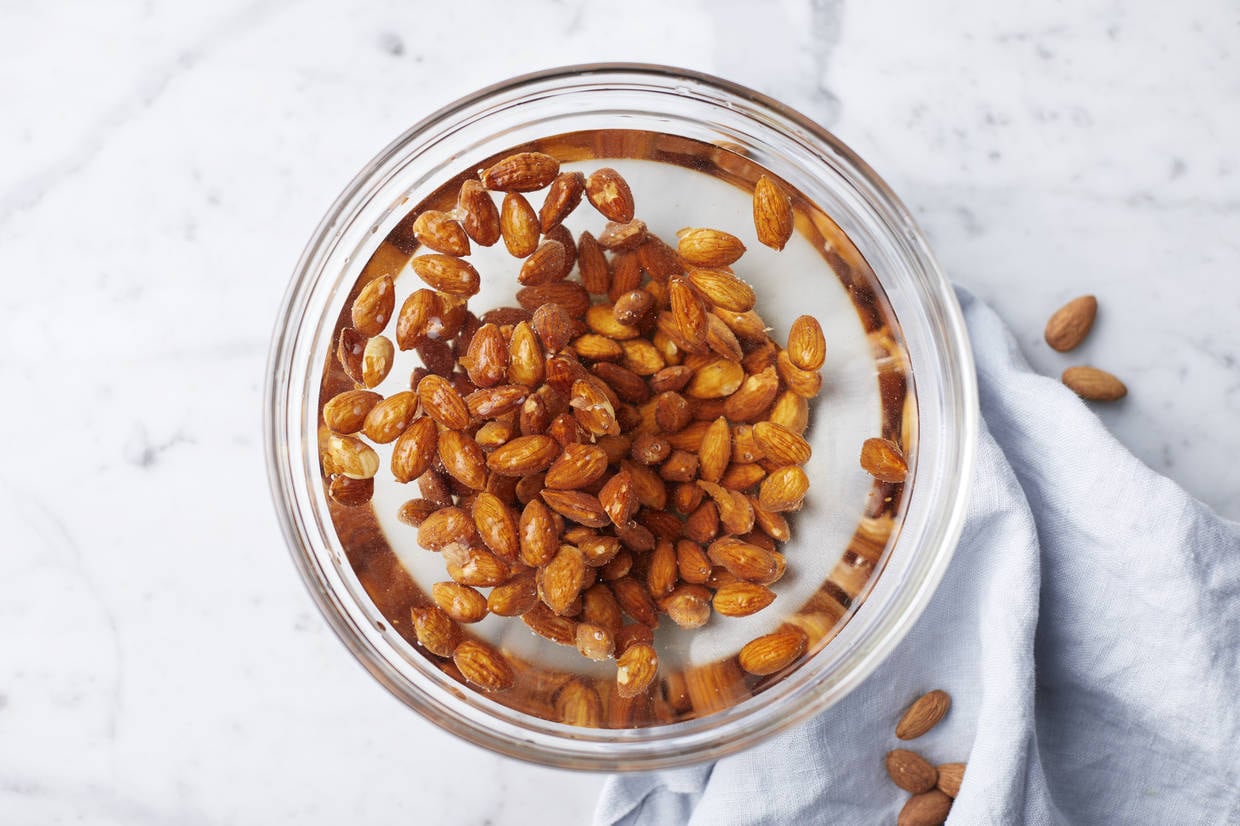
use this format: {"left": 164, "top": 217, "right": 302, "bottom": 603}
{"left": 595, "top": 290, "right": 1240, "bottom": 826}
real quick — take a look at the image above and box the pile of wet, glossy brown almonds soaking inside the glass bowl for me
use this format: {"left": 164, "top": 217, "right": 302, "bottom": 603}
{"left": 314, "top": 153, "right": 908, "bottom": 709}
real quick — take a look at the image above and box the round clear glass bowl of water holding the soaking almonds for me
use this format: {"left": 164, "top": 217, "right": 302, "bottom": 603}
{"left": 265, "top": 64, "right": 977, "bottom": 770}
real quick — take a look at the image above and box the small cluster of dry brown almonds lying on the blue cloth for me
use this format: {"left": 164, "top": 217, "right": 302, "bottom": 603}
{"left": 887, "top": 690, "right": 965, "bottom": 826}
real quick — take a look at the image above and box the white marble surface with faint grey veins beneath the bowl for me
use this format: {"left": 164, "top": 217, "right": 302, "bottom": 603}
{"left": 0, "top": 0, "right": 1240, "bottom": 826}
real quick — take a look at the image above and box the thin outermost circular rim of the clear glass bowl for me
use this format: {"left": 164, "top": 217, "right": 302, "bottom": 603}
{"left": 263, "top": 62, "right": 980, "bottom": 770}
